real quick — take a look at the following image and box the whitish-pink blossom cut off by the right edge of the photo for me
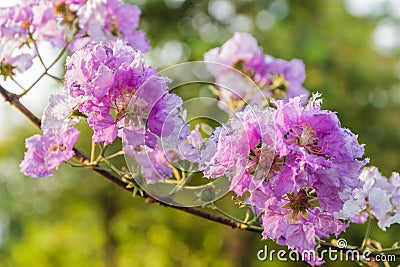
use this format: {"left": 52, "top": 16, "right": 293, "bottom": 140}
{"left": 335, "top": 167, "right": 400, "bottom": 231}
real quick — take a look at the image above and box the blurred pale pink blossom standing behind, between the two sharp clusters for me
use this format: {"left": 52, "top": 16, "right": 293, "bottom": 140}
{"left": 204, "top": 33, "right": 308, "bottom": 113}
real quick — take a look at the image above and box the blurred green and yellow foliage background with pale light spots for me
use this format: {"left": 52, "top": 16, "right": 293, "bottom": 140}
{"left": 0, "top": 0, "right": 400, "bottom": 267}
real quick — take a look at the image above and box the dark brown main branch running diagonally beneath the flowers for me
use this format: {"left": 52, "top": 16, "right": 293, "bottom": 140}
{"left": 0, "top": 85, "right": 255, "bottom": 232}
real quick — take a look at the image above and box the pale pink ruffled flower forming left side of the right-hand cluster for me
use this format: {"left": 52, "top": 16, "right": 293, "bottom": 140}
{"left": 200, "top": 106, "right": 275, "bottom": 195}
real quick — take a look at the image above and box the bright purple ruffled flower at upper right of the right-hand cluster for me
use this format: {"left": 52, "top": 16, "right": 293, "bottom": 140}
{"left": 275, "top": 94, "right": 367, "bottom": 200}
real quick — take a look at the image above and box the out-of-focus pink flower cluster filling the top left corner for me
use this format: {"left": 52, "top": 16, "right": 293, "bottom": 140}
{"left": 0, "top": 0, "right": 149, "bottom": 77}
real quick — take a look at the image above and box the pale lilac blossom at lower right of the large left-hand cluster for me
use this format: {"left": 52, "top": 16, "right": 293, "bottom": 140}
{"left": 121, "top": 86, "right": 202, "bottom": 184}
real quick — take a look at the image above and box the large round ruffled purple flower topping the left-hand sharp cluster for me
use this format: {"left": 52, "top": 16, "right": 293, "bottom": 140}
{"left": 65, "top": 40, "right": 170, "bottom": 144}
